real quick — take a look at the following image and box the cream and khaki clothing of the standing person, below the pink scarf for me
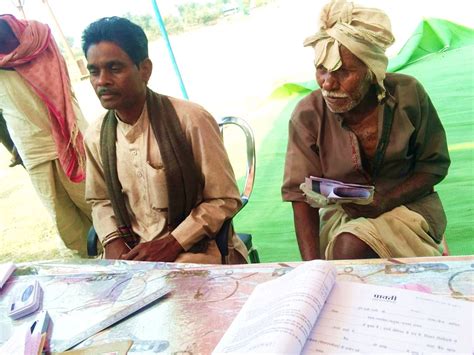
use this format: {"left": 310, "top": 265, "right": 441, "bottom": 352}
{"left": 0, "top": 70, "right": 92, "bottom": 257}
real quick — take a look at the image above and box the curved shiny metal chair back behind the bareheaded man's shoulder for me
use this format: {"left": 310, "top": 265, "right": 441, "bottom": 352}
{"left": 218, "top": 116, "right": 256, "bottom": 209}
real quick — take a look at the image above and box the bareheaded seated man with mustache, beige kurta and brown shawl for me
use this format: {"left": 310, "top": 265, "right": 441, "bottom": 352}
{"left": 82, "top": 17, "right": 247, "bottom": 264}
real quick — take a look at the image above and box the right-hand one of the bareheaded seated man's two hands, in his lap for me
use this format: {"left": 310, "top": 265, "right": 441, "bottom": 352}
{"left": 122, "top": 234, "right": 184, "bottom": 262}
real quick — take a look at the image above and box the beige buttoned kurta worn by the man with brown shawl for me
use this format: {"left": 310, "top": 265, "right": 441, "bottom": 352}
{"left": 85, "top": 94, "right": 246, "bottom": 263}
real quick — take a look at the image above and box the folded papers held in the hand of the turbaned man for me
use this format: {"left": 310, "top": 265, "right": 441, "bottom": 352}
{"left": 302, "top": 176, "right": 375, "bottom": 205}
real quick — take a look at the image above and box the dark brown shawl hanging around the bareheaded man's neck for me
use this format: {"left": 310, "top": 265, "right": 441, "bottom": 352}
{"left": 100, "top": 89, "right": 201, "bottom": 244}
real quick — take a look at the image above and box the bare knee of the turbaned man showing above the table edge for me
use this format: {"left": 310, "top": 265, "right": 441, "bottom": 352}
{"left": 333, "top": 232, "right": 379, "bottom": 260}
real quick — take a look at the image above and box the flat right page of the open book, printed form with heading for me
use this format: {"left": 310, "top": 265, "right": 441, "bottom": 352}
{"left": 303, "top": 282, "right": 474, "bottom": 354}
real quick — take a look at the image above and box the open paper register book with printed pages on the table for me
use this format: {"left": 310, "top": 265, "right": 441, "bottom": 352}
{"left": 213, "top": 261, "right": 474, "bottom": 354}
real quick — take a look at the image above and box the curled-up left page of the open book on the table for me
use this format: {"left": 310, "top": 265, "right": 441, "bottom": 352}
{"left": 213, "top": 260, "right": 336, "bottom": 354}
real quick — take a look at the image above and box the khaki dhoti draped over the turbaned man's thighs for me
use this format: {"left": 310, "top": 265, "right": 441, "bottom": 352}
{"left": 319, "top": 205, "right": 442, "bottom": 259}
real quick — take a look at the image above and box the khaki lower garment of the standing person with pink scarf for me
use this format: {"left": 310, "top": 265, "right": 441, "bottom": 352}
{"left": 28, "top": 159, "right": 92, "bottom": 257}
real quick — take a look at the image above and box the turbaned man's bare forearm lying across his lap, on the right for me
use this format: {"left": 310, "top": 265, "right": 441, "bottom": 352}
{"left": 342, "top": 173, "right": 443, "bottom": 218}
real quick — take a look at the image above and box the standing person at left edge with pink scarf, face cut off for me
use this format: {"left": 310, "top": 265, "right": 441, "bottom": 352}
{"left": 0, "top": 15, "right": 92, "bottom": 256}
